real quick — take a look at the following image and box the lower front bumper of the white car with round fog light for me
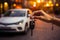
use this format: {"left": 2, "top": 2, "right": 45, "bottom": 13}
{"left": 0, "top": 26, "right": 24, "bottom": 32}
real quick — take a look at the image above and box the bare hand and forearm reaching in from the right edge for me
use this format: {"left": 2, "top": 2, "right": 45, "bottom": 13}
{"left": 33, "top": 11, "right": 60, "bottom": 27}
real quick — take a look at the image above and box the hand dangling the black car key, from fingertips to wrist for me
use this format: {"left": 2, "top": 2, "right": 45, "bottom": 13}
{"left": 32, "top": 10, "right": 53, "bottom": 21}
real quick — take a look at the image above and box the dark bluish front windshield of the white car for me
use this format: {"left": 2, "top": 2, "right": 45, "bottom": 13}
{"left": 4, "top": 10, "right": 25, "bottom": 17}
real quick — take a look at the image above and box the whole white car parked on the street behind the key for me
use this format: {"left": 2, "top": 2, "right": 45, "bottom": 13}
{"left": 0, "top": 9, "right": 32, "bottom": 32}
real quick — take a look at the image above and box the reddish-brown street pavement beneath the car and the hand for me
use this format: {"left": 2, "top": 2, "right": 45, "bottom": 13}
{"left": 0, "top": 20, "right": 60, "bottom": 40}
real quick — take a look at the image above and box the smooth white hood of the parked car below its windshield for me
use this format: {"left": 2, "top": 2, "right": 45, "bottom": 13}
{"left": 0, "top": 17, "right": 26, "bottom": 23}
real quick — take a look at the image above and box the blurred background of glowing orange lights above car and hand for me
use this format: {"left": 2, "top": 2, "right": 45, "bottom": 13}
{"left": 0, "top": 0, "right": 60, "bottom": 15}
